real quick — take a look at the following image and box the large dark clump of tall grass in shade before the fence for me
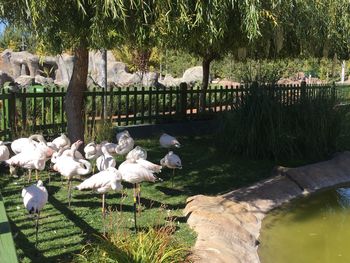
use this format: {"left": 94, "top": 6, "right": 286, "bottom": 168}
{"left": 218, "top": 86, "right": 350, "bottom": 159}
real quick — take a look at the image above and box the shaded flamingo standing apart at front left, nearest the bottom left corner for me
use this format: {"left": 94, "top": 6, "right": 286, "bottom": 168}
{"left": 22, "top": 180, "right": 48, "bottom": 246}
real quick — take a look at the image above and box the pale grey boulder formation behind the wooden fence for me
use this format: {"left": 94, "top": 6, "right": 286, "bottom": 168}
{"left": 0, "top": 49, "right": 202, "bottom": 87}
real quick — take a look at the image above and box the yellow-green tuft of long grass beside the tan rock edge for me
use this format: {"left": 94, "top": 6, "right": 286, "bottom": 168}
{"left": 77, "top": 225, "right": 188, "bottom": 263}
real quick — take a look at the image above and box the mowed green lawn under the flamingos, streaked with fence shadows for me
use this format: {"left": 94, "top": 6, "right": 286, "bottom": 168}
{"left": 0, "top": 136, "right": 300, "bottom": 262}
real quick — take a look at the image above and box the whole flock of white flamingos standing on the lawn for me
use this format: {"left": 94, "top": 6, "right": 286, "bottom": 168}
{"left": 0, "top": 130, "right": 182, "bottom": 245}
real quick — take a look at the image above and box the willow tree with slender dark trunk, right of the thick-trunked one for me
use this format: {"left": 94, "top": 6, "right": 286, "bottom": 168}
{"left": 164, "top": 0, "right": 276, "bottom": 109}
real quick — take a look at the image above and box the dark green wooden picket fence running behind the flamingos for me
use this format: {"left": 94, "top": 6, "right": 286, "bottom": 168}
{"left": 0, "top": 84, "right": 350, "bottom": 139}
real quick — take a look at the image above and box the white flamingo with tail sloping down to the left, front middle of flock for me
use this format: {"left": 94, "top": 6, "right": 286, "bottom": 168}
{"left": 75, "top": 167, "right": 123, "bottom": 223}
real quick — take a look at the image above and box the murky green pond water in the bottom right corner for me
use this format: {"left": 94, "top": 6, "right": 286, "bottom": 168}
{"left": 258, "top": 188, "right": 350, "bottom": 263}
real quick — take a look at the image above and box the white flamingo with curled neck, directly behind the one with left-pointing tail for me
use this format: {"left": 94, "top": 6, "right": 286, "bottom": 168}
{"left": 53, "top": 140, "right": 91, "bottom": 207}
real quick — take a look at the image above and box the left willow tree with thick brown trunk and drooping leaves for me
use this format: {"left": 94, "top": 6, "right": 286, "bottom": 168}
{"left": 0, "top": 0, "right": 163, "bottom": 145}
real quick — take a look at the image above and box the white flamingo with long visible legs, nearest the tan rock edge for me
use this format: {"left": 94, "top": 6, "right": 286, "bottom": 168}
{"left": 118, "top": 159, "right": 162, "bottom": 231}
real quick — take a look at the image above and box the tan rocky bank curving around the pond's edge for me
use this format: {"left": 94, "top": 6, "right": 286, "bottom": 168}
{"left": 184, "top": 152, "right": 350, "bottom": 263}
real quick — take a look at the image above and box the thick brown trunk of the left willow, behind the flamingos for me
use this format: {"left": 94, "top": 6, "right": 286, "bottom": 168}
{"left": 65, "top": 47, "right": 89, "bottom": 150}
